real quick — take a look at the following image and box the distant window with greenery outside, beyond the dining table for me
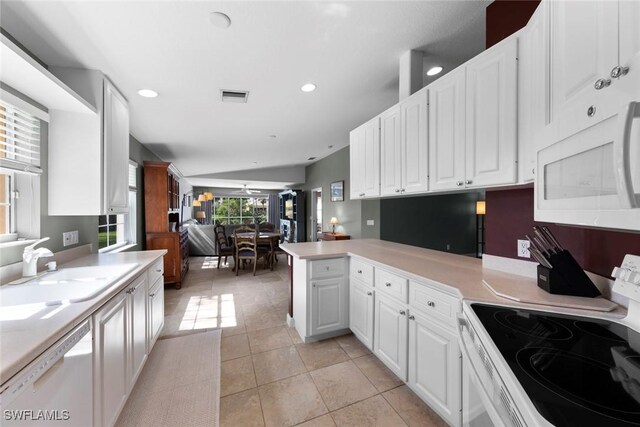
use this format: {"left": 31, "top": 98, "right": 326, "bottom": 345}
{"left": 211, "top": 197, "right": 269, "bottom": 224}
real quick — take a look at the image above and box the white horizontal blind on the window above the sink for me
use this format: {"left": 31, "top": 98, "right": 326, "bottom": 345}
{"left": 0, "top": 100, "right": 42, "bottom": 174}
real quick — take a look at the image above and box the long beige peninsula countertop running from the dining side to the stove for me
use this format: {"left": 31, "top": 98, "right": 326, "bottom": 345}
{"left": 281, "top": 239, "right": 626, "bottom": 318}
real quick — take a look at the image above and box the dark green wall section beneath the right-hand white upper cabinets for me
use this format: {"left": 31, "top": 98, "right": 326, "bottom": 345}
{"left": 380, "top": 193, "right": 484, "bottom": 254}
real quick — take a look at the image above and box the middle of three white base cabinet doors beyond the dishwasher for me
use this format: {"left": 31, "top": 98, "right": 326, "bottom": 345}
{"left": 128, "top": 274, "right": 147, "bottom": 388}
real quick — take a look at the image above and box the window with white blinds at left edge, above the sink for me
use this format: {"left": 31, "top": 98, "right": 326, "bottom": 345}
{"left": 0, "top": 98, "right": 42, "bottom": 242}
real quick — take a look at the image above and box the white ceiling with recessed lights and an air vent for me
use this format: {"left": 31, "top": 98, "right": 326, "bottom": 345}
{"left": 0, "top": 0, "right": 488, "bottom": 188}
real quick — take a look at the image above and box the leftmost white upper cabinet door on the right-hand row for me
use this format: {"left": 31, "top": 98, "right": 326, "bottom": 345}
{"left": 349, "top": 117, "right": 380, "bottom": 199}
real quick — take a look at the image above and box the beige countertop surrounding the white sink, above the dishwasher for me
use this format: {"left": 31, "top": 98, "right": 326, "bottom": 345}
{"left": 0, "top": 250, "right": 167, "bottom": 384}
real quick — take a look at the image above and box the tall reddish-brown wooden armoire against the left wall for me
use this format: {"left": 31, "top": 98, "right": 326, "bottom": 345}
{"left": 144, "top": 162, "right": 189, "bottom": 289}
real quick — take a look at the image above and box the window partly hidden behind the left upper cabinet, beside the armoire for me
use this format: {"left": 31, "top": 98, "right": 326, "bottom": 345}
{"left": 98, "top": 160, "right": 138, "bottom": 252}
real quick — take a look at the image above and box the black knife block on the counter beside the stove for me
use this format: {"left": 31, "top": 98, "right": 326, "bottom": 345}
{"left": 538, "top": 250, "right": 600, "bottom": 298}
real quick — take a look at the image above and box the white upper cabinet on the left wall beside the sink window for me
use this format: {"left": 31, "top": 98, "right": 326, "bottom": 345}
{"left": 48, "top": 68, "right": 129, "bottom": 215}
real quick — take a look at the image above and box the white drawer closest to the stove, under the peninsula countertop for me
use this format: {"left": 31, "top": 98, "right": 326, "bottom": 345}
{"left": 409, "top": 281, "right": 460, "bottom": 326}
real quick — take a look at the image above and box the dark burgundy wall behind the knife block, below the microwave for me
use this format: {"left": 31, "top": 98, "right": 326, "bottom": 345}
{"left": 485, "top": 188, "right": 640, "bottom": 277}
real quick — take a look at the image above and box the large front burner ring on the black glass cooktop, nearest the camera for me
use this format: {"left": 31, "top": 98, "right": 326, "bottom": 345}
{"left": 516, "top": 347, "right": 640, "bottom": 424}
